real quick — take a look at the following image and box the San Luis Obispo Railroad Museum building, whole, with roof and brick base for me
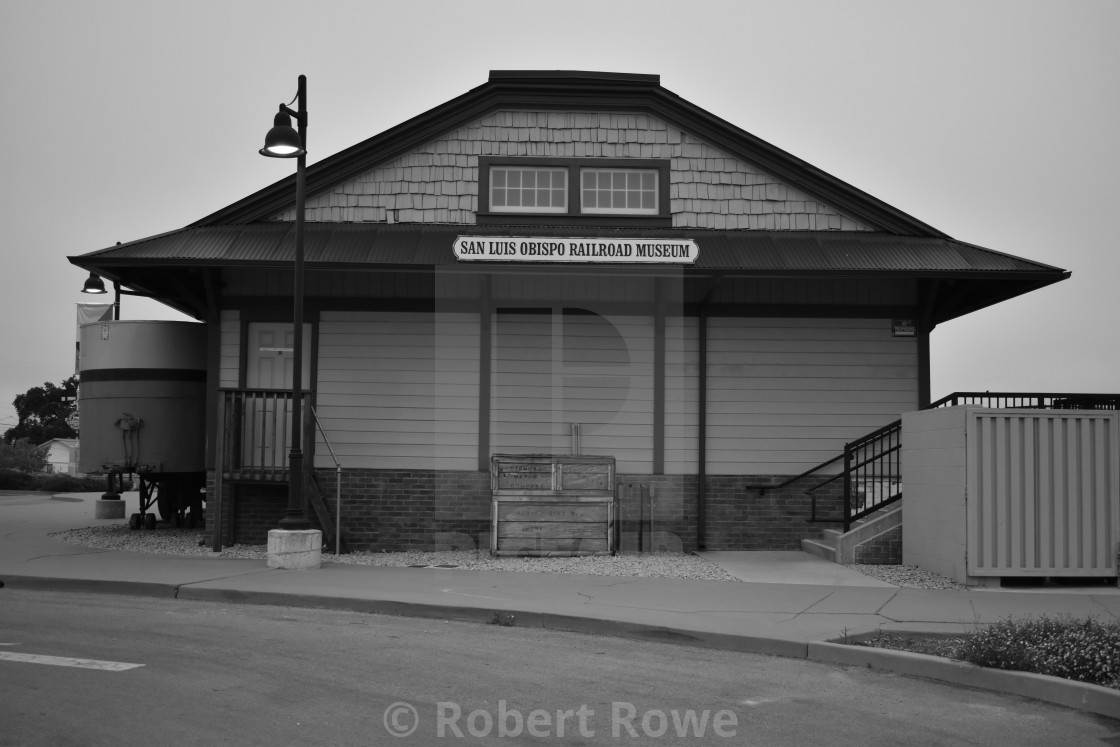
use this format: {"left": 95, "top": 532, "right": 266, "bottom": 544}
{"left": 71, "top": 71, "right": 1068, "bottom": 551}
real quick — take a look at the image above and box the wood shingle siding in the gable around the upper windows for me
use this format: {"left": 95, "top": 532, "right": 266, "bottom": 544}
{"left": 273, "top": 111, "right": 871, "bottom": 231}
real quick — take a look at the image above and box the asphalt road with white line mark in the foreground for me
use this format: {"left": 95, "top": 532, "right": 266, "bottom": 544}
{"left": 0, "top": 589, "right": 1120, "bottom": 747}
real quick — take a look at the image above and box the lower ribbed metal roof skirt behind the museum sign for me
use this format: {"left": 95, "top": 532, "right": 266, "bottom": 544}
{"left": 71, "top": 222, "right": 1065, "bottom": 274}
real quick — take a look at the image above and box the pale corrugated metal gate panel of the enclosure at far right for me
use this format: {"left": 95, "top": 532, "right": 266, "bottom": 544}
{"left": 965, "top": 409, "right": 1120, "bottom": 577}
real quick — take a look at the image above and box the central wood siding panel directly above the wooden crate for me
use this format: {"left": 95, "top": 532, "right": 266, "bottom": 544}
{"left": 491, "top": 310, "right": 653, "bottom": 473}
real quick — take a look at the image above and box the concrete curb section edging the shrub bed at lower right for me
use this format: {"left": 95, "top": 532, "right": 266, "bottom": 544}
{"left": 808, "top": 641, "right": 1120, "bottom": 719}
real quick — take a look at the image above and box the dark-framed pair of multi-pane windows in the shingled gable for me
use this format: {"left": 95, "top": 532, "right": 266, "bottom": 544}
{"left": 478, "top": 157, "right": 670, "bottom": 225}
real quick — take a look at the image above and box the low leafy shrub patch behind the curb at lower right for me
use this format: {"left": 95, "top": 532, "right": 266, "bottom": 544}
{"left": 956, "top": 616, "right": 1120, "bottom": 688}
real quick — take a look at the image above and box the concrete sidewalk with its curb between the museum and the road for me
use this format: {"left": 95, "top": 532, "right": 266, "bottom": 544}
{"left": 0, "top": 494, "right": 1120, "bottom": 717}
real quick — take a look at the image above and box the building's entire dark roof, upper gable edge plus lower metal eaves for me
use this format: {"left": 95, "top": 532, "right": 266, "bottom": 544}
{"left": 69, "top": 71, "right": 1070, "bottom": 321}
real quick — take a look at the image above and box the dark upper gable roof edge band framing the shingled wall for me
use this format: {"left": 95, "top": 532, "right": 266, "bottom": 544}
{"left": 190, "top": 71, "right": 948, "bottom": 237}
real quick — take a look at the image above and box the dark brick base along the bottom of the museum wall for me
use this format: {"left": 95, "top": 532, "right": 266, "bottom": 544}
{"left": 206, "top": 469, "right": 842, "bottom": 552}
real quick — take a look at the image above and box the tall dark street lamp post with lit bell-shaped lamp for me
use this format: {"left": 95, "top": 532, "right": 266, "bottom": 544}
{"left": 260, "top": 75, "right": 311, "bottom": 530}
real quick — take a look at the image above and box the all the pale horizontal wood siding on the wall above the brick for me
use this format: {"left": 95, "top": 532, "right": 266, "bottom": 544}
{"left": 227, "top": 304, "right": 918, "bottom": 475}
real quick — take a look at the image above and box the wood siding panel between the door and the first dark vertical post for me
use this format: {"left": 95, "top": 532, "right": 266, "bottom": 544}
{"left": 316, "top": 311, "right": 479, "bottom": 469}
